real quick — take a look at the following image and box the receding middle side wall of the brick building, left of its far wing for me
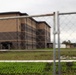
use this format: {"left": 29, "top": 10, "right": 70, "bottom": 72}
{"left": 21, "top": 18, "right": 36, "bottom": 49}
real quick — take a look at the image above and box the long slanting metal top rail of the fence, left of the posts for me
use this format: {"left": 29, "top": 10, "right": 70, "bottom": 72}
{"left": 0, "top": 13, "right": 55, "bottom": 20}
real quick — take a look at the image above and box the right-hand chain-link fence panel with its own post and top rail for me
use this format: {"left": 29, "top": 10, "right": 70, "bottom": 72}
{"left": 54, "top": 12, "right": 76, "bottom": 75}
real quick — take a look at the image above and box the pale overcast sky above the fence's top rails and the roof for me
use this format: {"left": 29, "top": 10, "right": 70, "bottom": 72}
{"left": 0, "top": 0, "right": 76, "bottom": 15}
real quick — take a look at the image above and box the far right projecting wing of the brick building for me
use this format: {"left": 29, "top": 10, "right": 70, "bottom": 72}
{"left": 36, "top": 22, "right": 50, "bottom": 48}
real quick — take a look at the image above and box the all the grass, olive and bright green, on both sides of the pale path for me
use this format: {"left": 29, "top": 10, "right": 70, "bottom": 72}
{"left": 0, "top": 49, "right": 76, "bottom": 75}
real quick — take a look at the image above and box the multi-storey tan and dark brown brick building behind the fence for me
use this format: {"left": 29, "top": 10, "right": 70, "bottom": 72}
{"left": 0, "top": 12, "right": 51, "bottom": 49}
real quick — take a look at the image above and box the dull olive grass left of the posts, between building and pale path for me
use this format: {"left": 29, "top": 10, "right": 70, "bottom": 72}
{"left": 0, "top": 51, "right": 52, "bottom": 60}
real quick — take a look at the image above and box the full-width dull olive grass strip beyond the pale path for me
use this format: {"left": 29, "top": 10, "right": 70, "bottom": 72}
{"left": 0, "top": 49, "right": 76, "bottom": 60}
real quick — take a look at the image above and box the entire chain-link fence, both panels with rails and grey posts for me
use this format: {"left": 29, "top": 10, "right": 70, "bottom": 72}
{"left": 0, "top": 12, "right": 76, "bottom": 75}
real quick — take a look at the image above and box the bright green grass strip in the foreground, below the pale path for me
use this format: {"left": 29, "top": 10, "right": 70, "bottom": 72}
{"left": 0, "top": 62, "right": 76, "bottom": 75}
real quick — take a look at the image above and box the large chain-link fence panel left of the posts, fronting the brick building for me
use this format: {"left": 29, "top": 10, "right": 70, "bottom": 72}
{"left": 0, "top": 12, "right": 54, "bottom": 75}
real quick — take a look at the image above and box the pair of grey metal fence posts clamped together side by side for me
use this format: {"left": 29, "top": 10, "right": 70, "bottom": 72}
{"left": 53, "top": 12, "right": 61, "bottom": 75}
